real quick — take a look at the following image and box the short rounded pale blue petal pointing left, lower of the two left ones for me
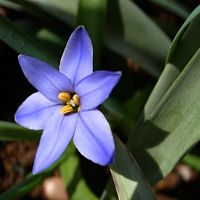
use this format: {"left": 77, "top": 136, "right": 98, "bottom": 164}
{"left": 15, "top": 92, "right": 60, "bottom": 130}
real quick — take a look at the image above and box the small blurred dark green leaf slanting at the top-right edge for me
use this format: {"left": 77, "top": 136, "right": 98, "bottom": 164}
{"left": 150, "top": 0, "right": 189, "bottom": 19}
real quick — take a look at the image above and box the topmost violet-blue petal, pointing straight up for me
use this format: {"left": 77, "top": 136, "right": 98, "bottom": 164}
{"left": 60, "top": 26, "right": 93, "bottom": 83}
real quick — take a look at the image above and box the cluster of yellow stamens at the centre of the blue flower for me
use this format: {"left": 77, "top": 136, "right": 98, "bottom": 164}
{"left": 58, "top": 92, "right": 80, "bottom": 114}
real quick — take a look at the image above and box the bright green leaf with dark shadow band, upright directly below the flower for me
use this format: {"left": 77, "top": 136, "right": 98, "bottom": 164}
{"left": 60, "top": 154, "right": 97, "bottom": 200}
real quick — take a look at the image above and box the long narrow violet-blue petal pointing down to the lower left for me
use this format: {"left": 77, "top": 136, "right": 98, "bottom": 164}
{"left": 33, "top": 110, "right": 78, "bottom": 174}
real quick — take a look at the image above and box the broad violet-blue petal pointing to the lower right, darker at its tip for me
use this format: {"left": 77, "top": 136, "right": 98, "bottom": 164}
{"left": 74, "top": 110, "right": 115, "bottom": 166}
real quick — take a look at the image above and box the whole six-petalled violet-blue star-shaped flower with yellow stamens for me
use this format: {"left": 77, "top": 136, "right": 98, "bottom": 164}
{"left": 15, "top": 26, "right": 121, "bottom": 174}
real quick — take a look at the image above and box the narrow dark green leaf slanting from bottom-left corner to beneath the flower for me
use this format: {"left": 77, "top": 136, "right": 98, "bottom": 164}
{"left": 0, "top": 145, "right": 74, "bottom": 200}
